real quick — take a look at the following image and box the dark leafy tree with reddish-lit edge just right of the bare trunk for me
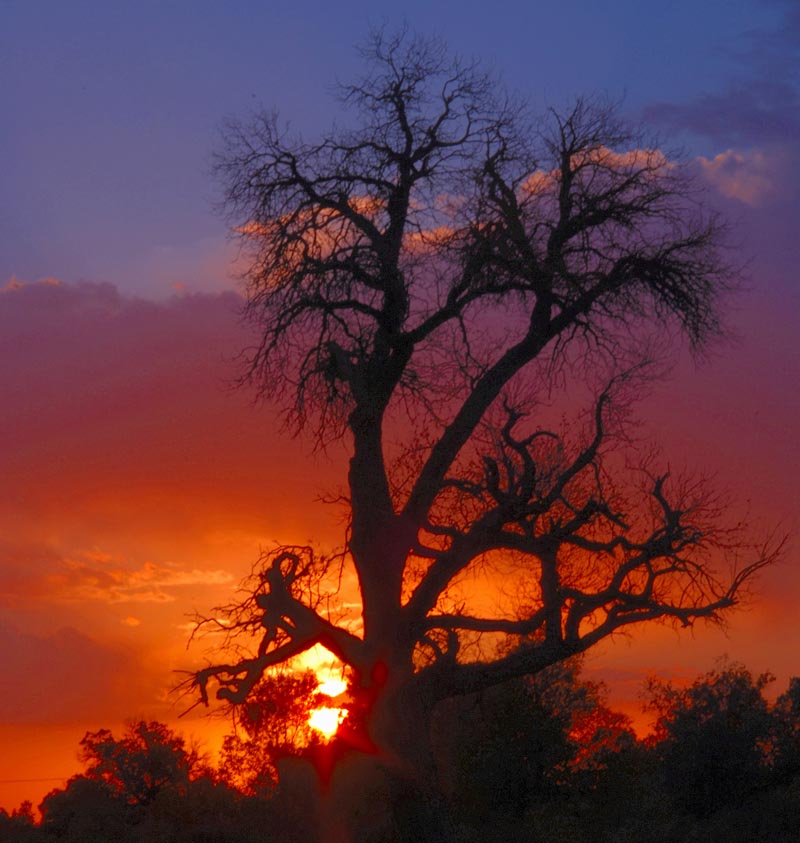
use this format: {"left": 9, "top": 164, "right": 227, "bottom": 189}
{"left": 433, "top": 658, "right": 636, "bottom": 822}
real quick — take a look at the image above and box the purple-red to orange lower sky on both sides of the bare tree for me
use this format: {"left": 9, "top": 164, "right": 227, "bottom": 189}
{"left": 0, "top": 274, "right": 800, "bottom": 809}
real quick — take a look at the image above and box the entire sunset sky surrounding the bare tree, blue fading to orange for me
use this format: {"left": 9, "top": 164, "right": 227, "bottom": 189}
{"left": 0, "top": 0, "right": 800, "bottom": 809}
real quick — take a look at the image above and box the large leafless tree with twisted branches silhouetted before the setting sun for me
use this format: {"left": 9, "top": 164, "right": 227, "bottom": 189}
{"left": 189, "top": 35, "right": 775, "bottom": 816}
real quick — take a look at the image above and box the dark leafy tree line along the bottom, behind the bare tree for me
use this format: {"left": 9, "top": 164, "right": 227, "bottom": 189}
{"left": 0, "top": 659, "right": 800, "bottom": 843}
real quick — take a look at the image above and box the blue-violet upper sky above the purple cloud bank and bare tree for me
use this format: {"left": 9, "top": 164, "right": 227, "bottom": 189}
{"left": 0, "top": 0, "right": 797, "bottom": 295}
